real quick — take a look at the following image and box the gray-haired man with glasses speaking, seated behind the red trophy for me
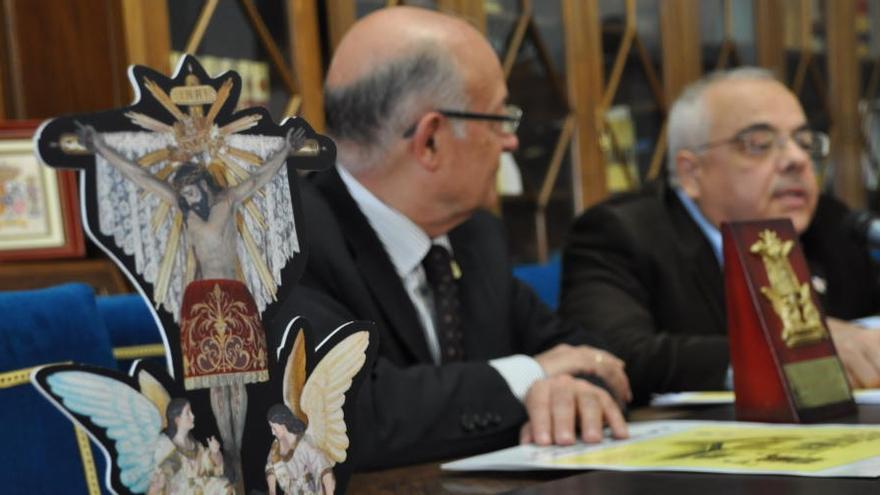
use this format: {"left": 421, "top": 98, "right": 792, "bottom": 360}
{"left": 560, "top": 68, "right": 880, "bottom": 402}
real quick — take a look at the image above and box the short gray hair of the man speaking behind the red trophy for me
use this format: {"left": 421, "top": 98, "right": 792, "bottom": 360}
{"left": 666, "top": 67, "right": 779, "bottom": 185}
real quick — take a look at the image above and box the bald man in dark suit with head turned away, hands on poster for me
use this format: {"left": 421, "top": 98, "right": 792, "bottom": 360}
{"left": 276, "top": 7, "right": 630, "bottom": 468}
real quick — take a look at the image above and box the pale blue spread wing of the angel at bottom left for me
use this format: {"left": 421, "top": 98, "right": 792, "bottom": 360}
{"left": 46, "top": 370, "right": 168, "bottom": 493}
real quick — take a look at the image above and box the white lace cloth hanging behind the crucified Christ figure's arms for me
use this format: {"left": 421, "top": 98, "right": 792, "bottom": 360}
{"left": 96, "top": 132, "right": 300, "bottom": 320}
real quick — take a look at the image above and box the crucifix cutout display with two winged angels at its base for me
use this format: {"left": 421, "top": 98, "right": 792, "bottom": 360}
{"left": 33, "top": 56, "right": 375, "bottom": 493}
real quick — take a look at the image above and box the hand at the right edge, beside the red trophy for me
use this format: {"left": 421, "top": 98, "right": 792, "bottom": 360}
{"left": 826, "top": 318, "right": 880, "bottom": 388}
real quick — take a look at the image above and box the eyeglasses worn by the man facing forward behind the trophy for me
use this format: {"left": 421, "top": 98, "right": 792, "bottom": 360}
{"left": 694, "top": 124, "right": 830, "bottom": 159}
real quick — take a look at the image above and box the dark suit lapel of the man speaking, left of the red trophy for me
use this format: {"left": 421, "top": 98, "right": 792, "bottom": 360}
{"left": 661, "top": 187, "right": 727, "bottom": 329}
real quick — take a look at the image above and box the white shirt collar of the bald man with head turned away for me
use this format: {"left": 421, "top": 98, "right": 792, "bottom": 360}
{"left": 336, "top": 165, "right": 452, "bottom": 278}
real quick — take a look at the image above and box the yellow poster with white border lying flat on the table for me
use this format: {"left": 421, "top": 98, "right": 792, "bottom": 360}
{"left": 442, "top": 420, "right": 880, "bottom": 478}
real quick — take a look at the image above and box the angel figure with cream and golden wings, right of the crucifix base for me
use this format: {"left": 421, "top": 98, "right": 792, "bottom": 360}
{"left": 266, "top": 331, "right": 369, "bottom": 495}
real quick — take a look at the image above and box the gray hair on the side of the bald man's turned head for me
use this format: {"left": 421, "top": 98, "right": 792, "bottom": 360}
{"left": 324, "top": 45, "right": 468, "bottom": 172}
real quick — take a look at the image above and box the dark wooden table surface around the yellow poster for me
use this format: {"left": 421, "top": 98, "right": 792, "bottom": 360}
{"left": 346, "top": 405, "right": 880, "bottom": 495}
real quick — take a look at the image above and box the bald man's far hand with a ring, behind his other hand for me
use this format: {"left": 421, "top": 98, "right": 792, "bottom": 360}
{"left": 535, "top": 344, "right": 632, "bottom": 403}
